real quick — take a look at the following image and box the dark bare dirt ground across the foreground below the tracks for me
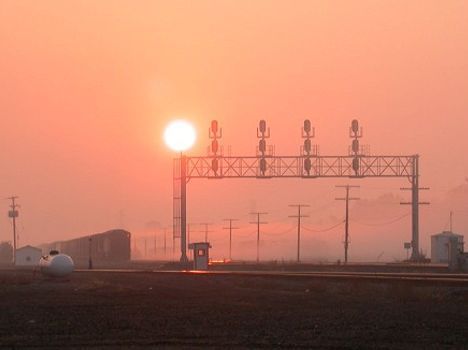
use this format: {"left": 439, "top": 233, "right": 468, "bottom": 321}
{"left": 0, "top": 271, "right": 468, "bottom": 349}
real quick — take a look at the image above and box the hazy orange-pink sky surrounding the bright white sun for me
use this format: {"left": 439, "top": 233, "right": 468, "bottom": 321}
{"left": 0, "top": 0, "right": 468, "bottom": 259}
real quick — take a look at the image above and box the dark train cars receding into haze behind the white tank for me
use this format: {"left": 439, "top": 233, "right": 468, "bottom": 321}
{"left": 41, "top": 230, "right": 131, "bottom": 266}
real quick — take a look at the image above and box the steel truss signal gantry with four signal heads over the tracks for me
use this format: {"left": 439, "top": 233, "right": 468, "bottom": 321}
{"left": 173, "top": 120, "right": 427, "bottom": 262}
